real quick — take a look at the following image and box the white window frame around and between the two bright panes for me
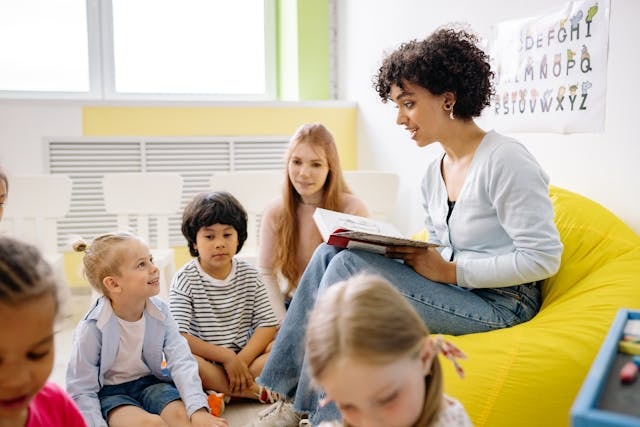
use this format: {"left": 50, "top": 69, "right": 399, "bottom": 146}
{"left": 0, "top": 0, "right": 277, "bottom": 101}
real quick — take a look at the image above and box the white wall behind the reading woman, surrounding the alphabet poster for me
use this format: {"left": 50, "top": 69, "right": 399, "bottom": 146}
{"left": 337, "top": 0, "right": 640, "bottom": 233}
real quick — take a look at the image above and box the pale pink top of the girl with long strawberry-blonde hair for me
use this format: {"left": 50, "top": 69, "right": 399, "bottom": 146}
{"left": 258, "top": 193, "right": 369, "bottom": 289}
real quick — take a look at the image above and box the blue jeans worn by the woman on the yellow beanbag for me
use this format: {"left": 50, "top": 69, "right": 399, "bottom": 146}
{"left": 259, "top": 244, "right": 540, "bottom": 425}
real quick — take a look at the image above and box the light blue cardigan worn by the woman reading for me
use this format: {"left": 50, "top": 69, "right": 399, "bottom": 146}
{"left": 422, "top": 131, "right": 562, "bottom": 288}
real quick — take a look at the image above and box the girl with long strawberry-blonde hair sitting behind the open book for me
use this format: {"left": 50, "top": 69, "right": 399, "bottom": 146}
{"left": 258, "top": 123, "right": 369, "bottom": 319}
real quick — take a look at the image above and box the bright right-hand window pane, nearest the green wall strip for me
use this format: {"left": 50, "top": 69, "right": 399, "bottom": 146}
{"left": 108, "top": 0, "right": 268, "bottom": 97}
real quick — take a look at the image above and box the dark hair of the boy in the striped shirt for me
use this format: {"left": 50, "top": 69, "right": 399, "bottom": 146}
{"left": 182, "top": 191, "right": 247, "bottom": 257}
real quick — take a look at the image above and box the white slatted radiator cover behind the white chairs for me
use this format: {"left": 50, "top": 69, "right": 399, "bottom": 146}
{"left": 48, "top": 136, "right": 289, "bottom": 249}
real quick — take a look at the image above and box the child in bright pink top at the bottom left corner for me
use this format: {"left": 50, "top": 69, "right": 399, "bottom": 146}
{"left": 0, "top": 237, "right": 86, "bottom": 427}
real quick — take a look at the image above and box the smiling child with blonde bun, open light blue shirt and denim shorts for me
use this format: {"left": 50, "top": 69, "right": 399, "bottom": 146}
{"left": 67, "top": 233, "right": 227, "bottom": 426}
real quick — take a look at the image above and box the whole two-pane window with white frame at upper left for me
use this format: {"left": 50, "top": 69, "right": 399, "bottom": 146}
{"left": 0, "top": 0, "right": 276, "bottom": 100}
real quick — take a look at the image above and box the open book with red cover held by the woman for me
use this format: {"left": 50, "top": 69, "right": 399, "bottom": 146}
{"left": 313, "top": 208, "right": 438, "bottom": 254}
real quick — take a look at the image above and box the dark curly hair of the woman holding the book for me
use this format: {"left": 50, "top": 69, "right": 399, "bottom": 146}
{"left": 373, "top": 27, "right": 494, "bottom": 119}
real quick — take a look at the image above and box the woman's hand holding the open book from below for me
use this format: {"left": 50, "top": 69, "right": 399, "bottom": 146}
{"left": 385, "top": 246, "right": 458, "bottom": 283}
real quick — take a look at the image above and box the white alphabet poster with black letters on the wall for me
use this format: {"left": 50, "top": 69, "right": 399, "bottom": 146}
{"left": 485, "top": 0, "right": 610, "bottom": 133}
